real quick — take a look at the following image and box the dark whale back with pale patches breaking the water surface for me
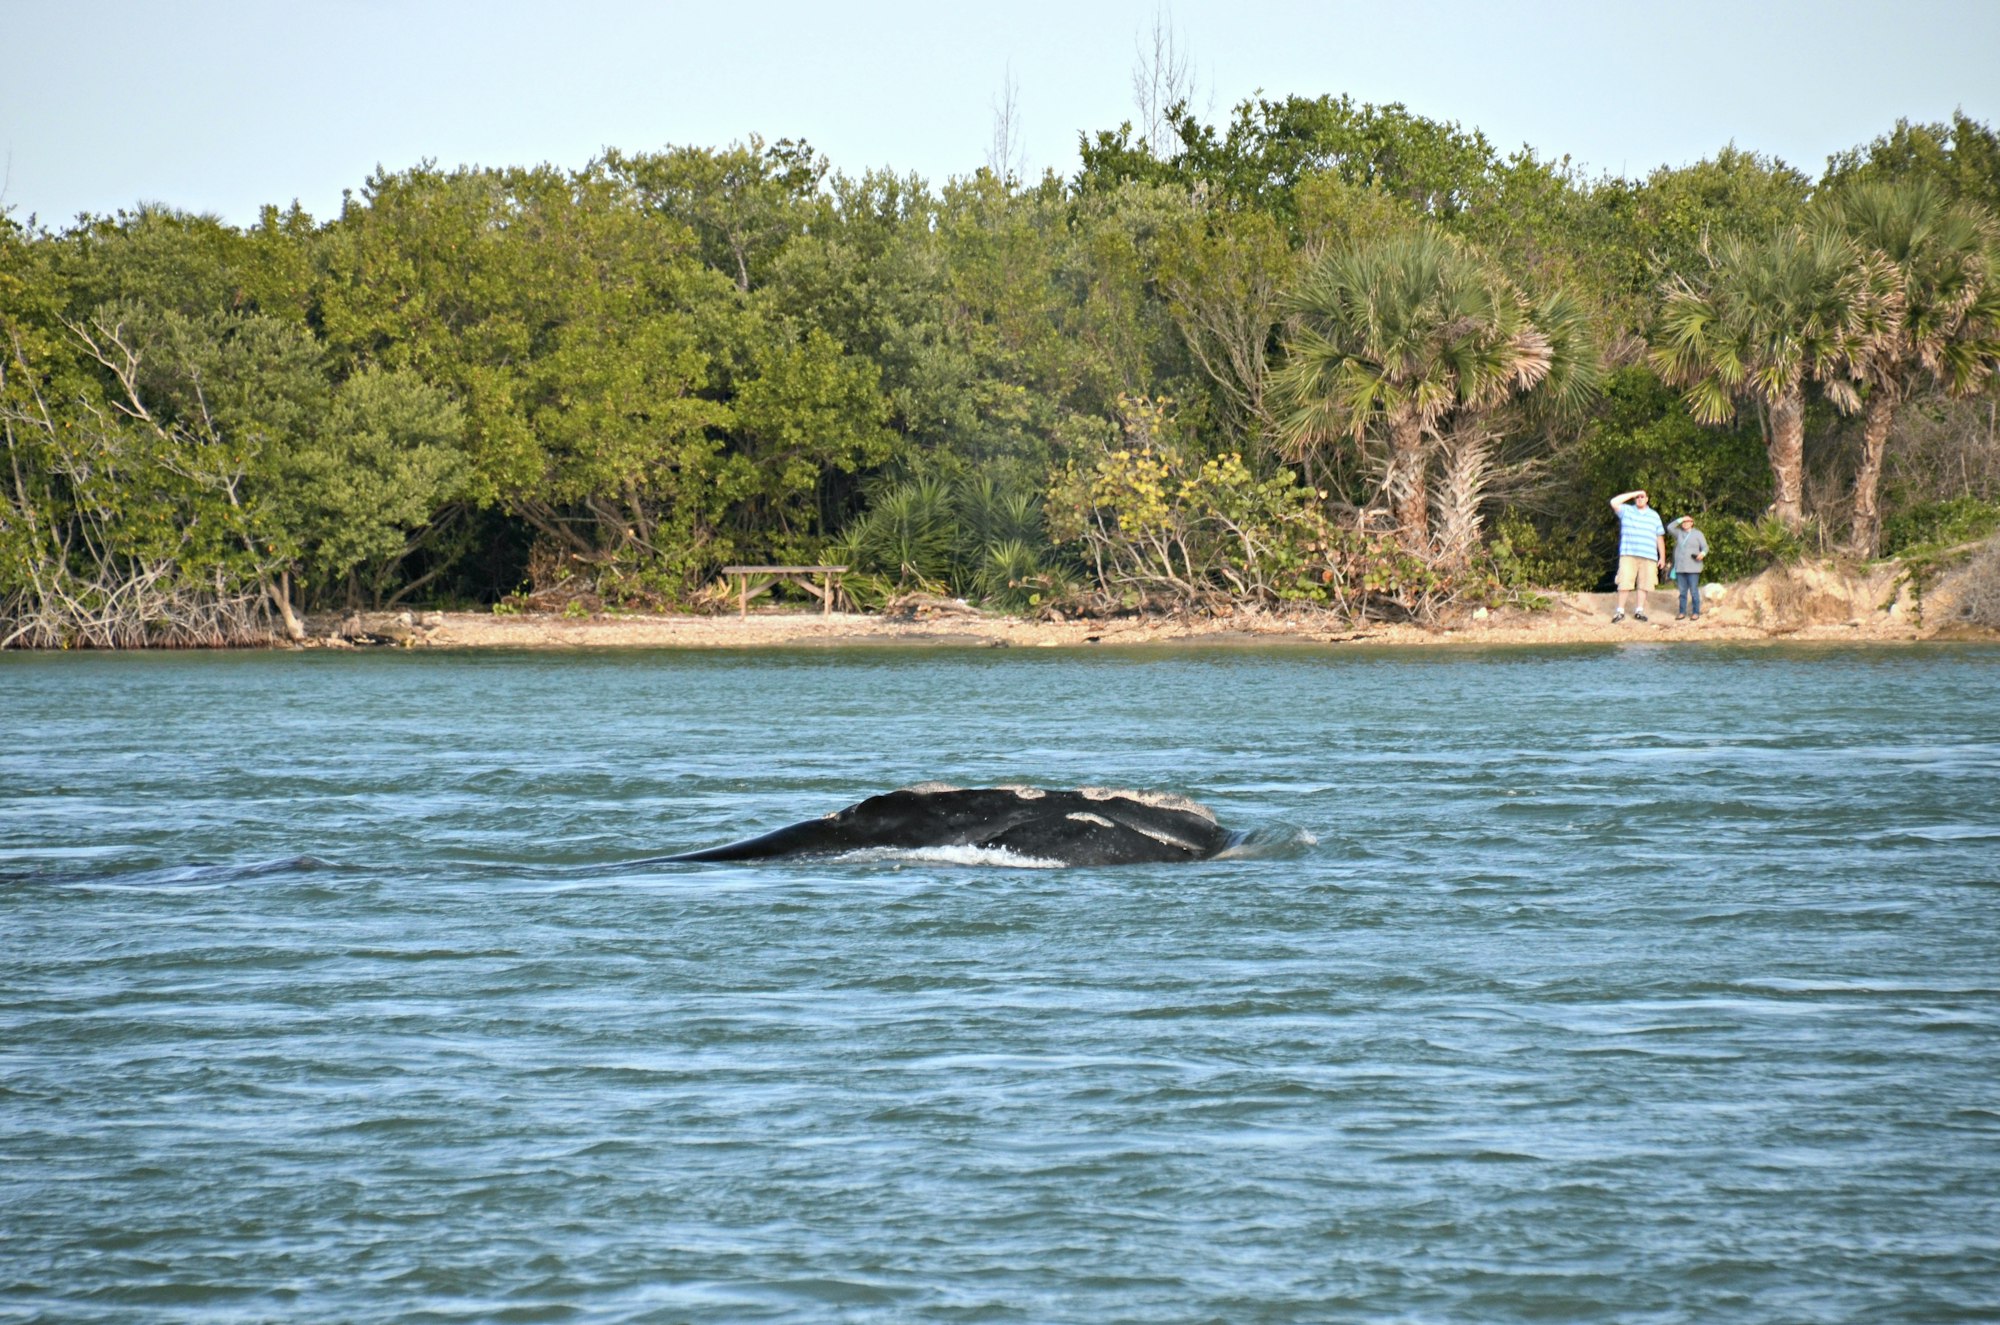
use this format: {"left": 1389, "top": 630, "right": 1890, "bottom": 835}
{"left": 668, "top": 785, "right": 1236, "bottom": 865}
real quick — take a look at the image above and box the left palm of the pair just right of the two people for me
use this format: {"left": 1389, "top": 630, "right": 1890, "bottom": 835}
{"left": 1650, "top": 226, "right": 1898, "bottom": 530}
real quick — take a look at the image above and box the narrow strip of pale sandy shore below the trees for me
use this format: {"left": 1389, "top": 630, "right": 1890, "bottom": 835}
{"left": 310, "top": 576, "right": 2000, "bottom": 648}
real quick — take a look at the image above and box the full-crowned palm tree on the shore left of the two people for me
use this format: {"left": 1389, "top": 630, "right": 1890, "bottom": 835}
{"left": 1272, "top": 230, "right": 1596, "bottom": 554}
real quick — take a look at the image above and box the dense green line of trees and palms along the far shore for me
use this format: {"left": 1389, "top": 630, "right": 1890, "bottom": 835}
{"left": 0, "top": 96, "right": 2000, "bottom": 646}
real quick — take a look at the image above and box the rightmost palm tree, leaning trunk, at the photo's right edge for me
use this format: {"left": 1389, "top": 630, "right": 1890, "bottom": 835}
{"left": 1828, "top": 180, "right": 2000, "bottom": 556}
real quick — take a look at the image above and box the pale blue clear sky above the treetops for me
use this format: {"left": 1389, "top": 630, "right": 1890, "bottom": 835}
{"left": 0, "top": 0, "right": 2000, "bottom": 228}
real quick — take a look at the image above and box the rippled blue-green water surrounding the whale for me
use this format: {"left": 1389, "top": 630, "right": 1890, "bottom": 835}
{"left": 0, "top": 646, "right": 2000, "bottom": 1321}
